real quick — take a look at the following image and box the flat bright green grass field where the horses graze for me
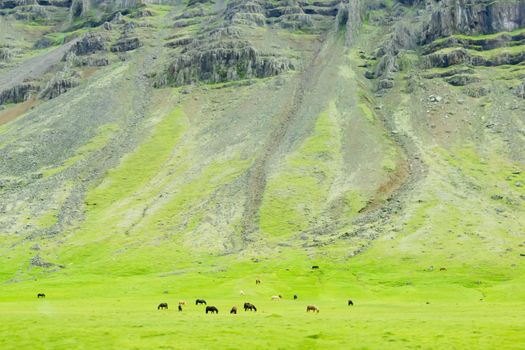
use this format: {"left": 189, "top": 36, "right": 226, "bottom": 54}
{"left": 0, "top": 257, "right": 525, "bottom": 349}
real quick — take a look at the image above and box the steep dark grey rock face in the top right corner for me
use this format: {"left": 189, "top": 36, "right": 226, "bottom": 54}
{"left": 423, "top": 0, "right": 525, "bottom": 43}
